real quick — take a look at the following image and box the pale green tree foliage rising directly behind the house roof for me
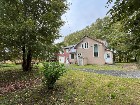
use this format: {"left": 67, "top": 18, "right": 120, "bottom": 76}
{"left": 64, "top": 17, "right": 133, "bottom": 62}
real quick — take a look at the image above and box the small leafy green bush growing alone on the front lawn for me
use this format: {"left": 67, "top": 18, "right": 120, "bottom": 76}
{"left": 43, "top": 62, "right": 66, "bottom": 89}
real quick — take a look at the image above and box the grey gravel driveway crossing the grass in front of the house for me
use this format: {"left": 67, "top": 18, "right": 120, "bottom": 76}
{"left": 74, "top": 69, "right": 140, "bottom": 78}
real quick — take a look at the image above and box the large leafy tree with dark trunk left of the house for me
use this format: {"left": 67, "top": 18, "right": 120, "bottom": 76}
{"left": 0, "top": 0, "right": 67, "bottom": 71}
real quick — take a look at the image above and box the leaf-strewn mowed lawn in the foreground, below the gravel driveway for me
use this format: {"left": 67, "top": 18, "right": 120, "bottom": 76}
{"left": 0, "top": 63, "right": 140, "bottom": 105}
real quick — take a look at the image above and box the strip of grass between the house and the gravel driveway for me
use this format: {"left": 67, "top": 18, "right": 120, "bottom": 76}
{"left": 68, "top": 63, "right": 137, "bottom": 70}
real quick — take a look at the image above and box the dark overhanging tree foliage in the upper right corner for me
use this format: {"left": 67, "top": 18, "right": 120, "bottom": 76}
{"left": 107, "top": 0, "right": 140, "bottom": 62}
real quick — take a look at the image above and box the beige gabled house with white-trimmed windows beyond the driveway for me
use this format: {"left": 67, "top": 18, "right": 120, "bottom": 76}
{"left": 59, "top": 36, "right": 113, "bottom": 65}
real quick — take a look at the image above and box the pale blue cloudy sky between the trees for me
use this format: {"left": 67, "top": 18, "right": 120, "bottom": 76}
{"left": 55, "top": 0, "right": 111, "bottom": 43}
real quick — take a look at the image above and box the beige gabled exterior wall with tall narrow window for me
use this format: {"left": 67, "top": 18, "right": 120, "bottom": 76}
{"left": 77, "top": 37, "right": 105, "bottom": 65}
